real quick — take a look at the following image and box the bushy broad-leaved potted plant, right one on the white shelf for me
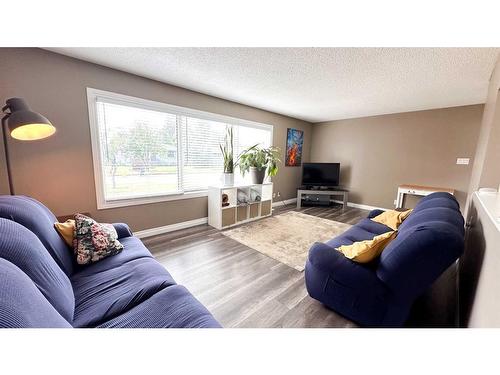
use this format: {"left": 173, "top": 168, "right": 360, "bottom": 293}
{"left": 239, "top": 146, "right": 281, "bottom": 184}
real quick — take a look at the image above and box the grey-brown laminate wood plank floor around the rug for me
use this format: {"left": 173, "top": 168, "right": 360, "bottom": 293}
{"left": 143, "top": 205, "right": 368, "bottom": 328}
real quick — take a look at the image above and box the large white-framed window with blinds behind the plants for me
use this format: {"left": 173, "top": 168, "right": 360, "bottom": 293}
{"left": 87, "top": 88, "right": 272, "bottom": 208}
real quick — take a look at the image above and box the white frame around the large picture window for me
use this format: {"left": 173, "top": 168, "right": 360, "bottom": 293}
{"left": 87, "top": 87, "right": 274, "bottom": 210}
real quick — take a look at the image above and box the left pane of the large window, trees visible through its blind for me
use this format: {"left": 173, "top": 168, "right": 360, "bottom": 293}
{"left": 97, "top": 101, "right": 182, "bottom": 200}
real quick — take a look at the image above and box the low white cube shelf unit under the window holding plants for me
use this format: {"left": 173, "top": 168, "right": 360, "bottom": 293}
{"left": 208, "top": 182, "right": 273, "bottom": 229}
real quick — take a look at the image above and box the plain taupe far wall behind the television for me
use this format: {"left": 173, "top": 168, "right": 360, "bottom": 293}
{"left": 311, "top": 105, "right": 483, "bottom": 212}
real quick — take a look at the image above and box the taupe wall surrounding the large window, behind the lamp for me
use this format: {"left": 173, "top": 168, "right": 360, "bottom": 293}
{"left": 0, "top": 48, "right": 311, "bottom": 230}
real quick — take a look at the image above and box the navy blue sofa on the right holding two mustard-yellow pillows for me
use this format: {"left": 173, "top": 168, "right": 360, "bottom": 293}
{"left": 305, "top": 193, "right": 464, "bottom": 327}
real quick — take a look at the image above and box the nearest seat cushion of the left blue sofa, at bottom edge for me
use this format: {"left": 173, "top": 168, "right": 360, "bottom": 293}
{"left": 99, "top": 285, "right": 220, "bottom": 328}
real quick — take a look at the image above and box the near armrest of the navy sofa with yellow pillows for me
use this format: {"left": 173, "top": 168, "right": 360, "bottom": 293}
{"left": 309, "top": 242, "right": 388, "bottom": 293}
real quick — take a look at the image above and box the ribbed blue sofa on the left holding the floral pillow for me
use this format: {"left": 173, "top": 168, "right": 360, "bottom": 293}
{"left": 0, "top": 196, "right": 220, "bottom": 328}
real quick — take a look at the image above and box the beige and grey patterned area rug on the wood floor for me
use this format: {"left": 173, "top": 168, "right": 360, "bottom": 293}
{"left": 222, "top": 211, "right": 351, "bottom": 271}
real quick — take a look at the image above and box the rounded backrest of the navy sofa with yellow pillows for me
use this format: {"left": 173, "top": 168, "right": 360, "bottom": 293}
{"left": 377, "top": 194, "right": 464, "bottom": 298}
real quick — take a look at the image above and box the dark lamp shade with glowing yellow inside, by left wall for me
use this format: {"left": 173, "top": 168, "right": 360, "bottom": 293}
{"left": 6, "top": 98, "right": 56, "bottom": 141}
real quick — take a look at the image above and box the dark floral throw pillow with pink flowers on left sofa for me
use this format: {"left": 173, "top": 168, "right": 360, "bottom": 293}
{"left": 73, "top": 214, "right": 123, "bottom": 264}
